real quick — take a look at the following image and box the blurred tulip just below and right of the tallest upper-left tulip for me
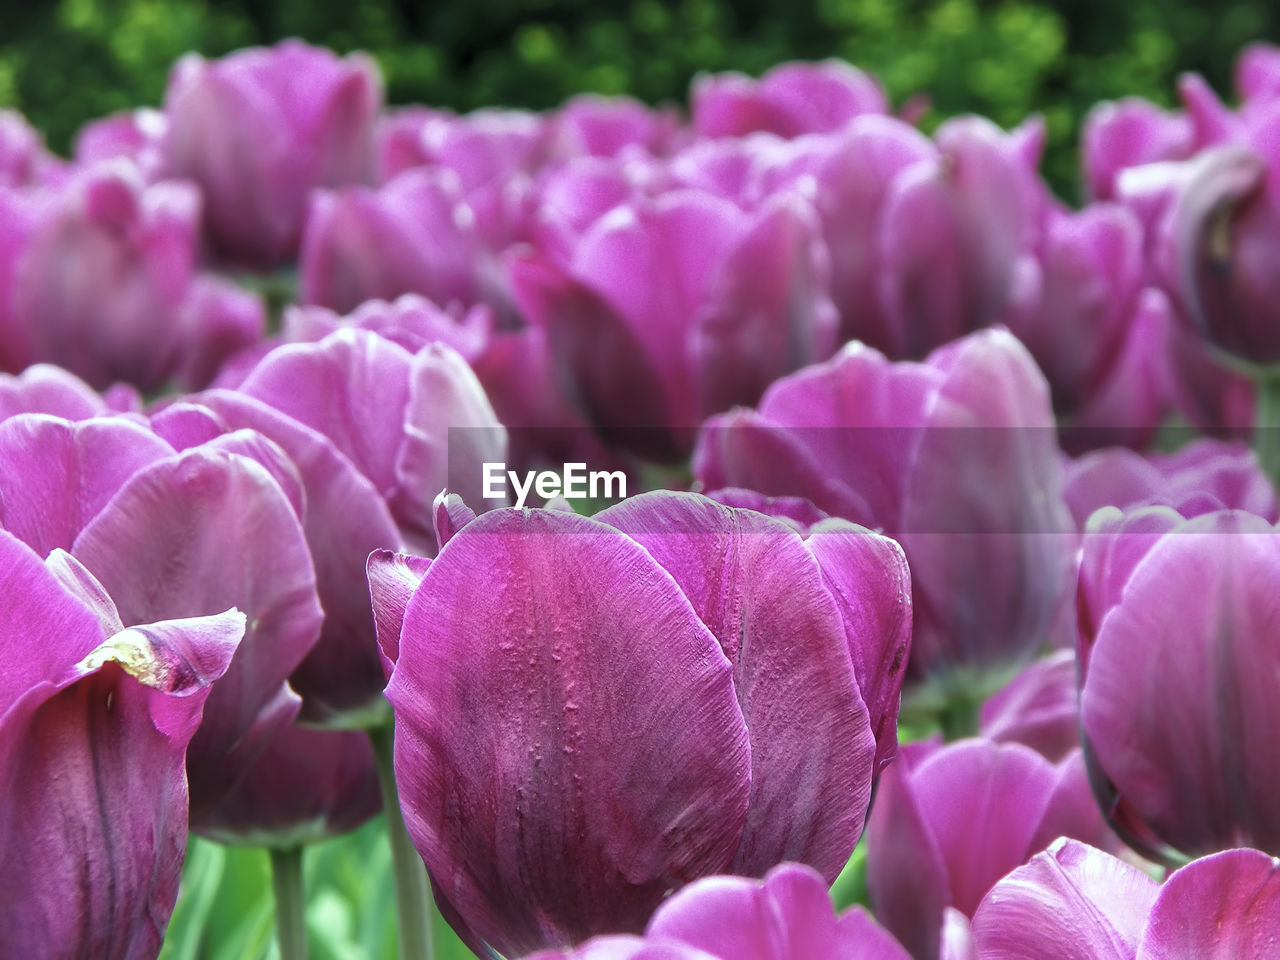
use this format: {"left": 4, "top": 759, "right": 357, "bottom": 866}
{"left": 301, "top": 169, "right": 497, "bottom": 312}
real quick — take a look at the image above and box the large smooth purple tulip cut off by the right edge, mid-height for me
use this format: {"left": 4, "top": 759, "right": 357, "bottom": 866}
{"left": 1078, "top": 507, "right": 1280, "bottom": 860}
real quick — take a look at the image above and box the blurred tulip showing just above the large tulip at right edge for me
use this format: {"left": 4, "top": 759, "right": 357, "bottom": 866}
{"left": 1062, "top": 438, "right": 1280, "bottom": 530}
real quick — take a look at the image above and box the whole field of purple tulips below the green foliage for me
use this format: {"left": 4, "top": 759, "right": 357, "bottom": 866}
{"left": 0, "top": 32, "right": 1280, "bottom": 960}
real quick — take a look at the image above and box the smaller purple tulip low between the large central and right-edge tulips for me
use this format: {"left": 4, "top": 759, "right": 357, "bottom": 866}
{"left": 867, "top": 740, "right": 1107, "bottom": 960}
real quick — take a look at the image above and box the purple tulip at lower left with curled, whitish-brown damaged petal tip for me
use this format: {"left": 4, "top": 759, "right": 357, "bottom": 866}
{"left": 0, "top": 531, "right": 244, "bottom": 960}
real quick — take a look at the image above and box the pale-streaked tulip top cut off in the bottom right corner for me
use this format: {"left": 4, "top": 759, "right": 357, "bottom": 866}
{"left": 973, "top": 838, "right": 1280, "bottom": 960}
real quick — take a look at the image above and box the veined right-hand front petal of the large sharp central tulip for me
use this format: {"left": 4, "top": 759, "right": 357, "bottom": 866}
{"left": 595, "top": 492, "right": 883, "bottom": 883}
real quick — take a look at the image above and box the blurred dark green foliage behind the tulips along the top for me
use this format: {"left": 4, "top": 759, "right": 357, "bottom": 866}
{"left": 0, "top": 0, "right": 1280, "bottom": 196}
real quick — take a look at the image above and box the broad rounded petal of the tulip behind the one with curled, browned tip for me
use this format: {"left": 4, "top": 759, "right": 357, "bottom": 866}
{"left": 72, "top": 448, "right": 323, "bottom": 822}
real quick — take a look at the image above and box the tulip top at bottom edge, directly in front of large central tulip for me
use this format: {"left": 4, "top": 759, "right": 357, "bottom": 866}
{"left": 529, "top": 864, "right": 972, "bottom": 960}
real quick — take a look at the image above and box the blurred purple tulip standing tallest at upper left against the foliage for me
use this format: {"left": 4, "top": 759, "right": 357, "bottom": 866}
{"left": 163, "top": 40, "right": 381, "bottom": 268}
